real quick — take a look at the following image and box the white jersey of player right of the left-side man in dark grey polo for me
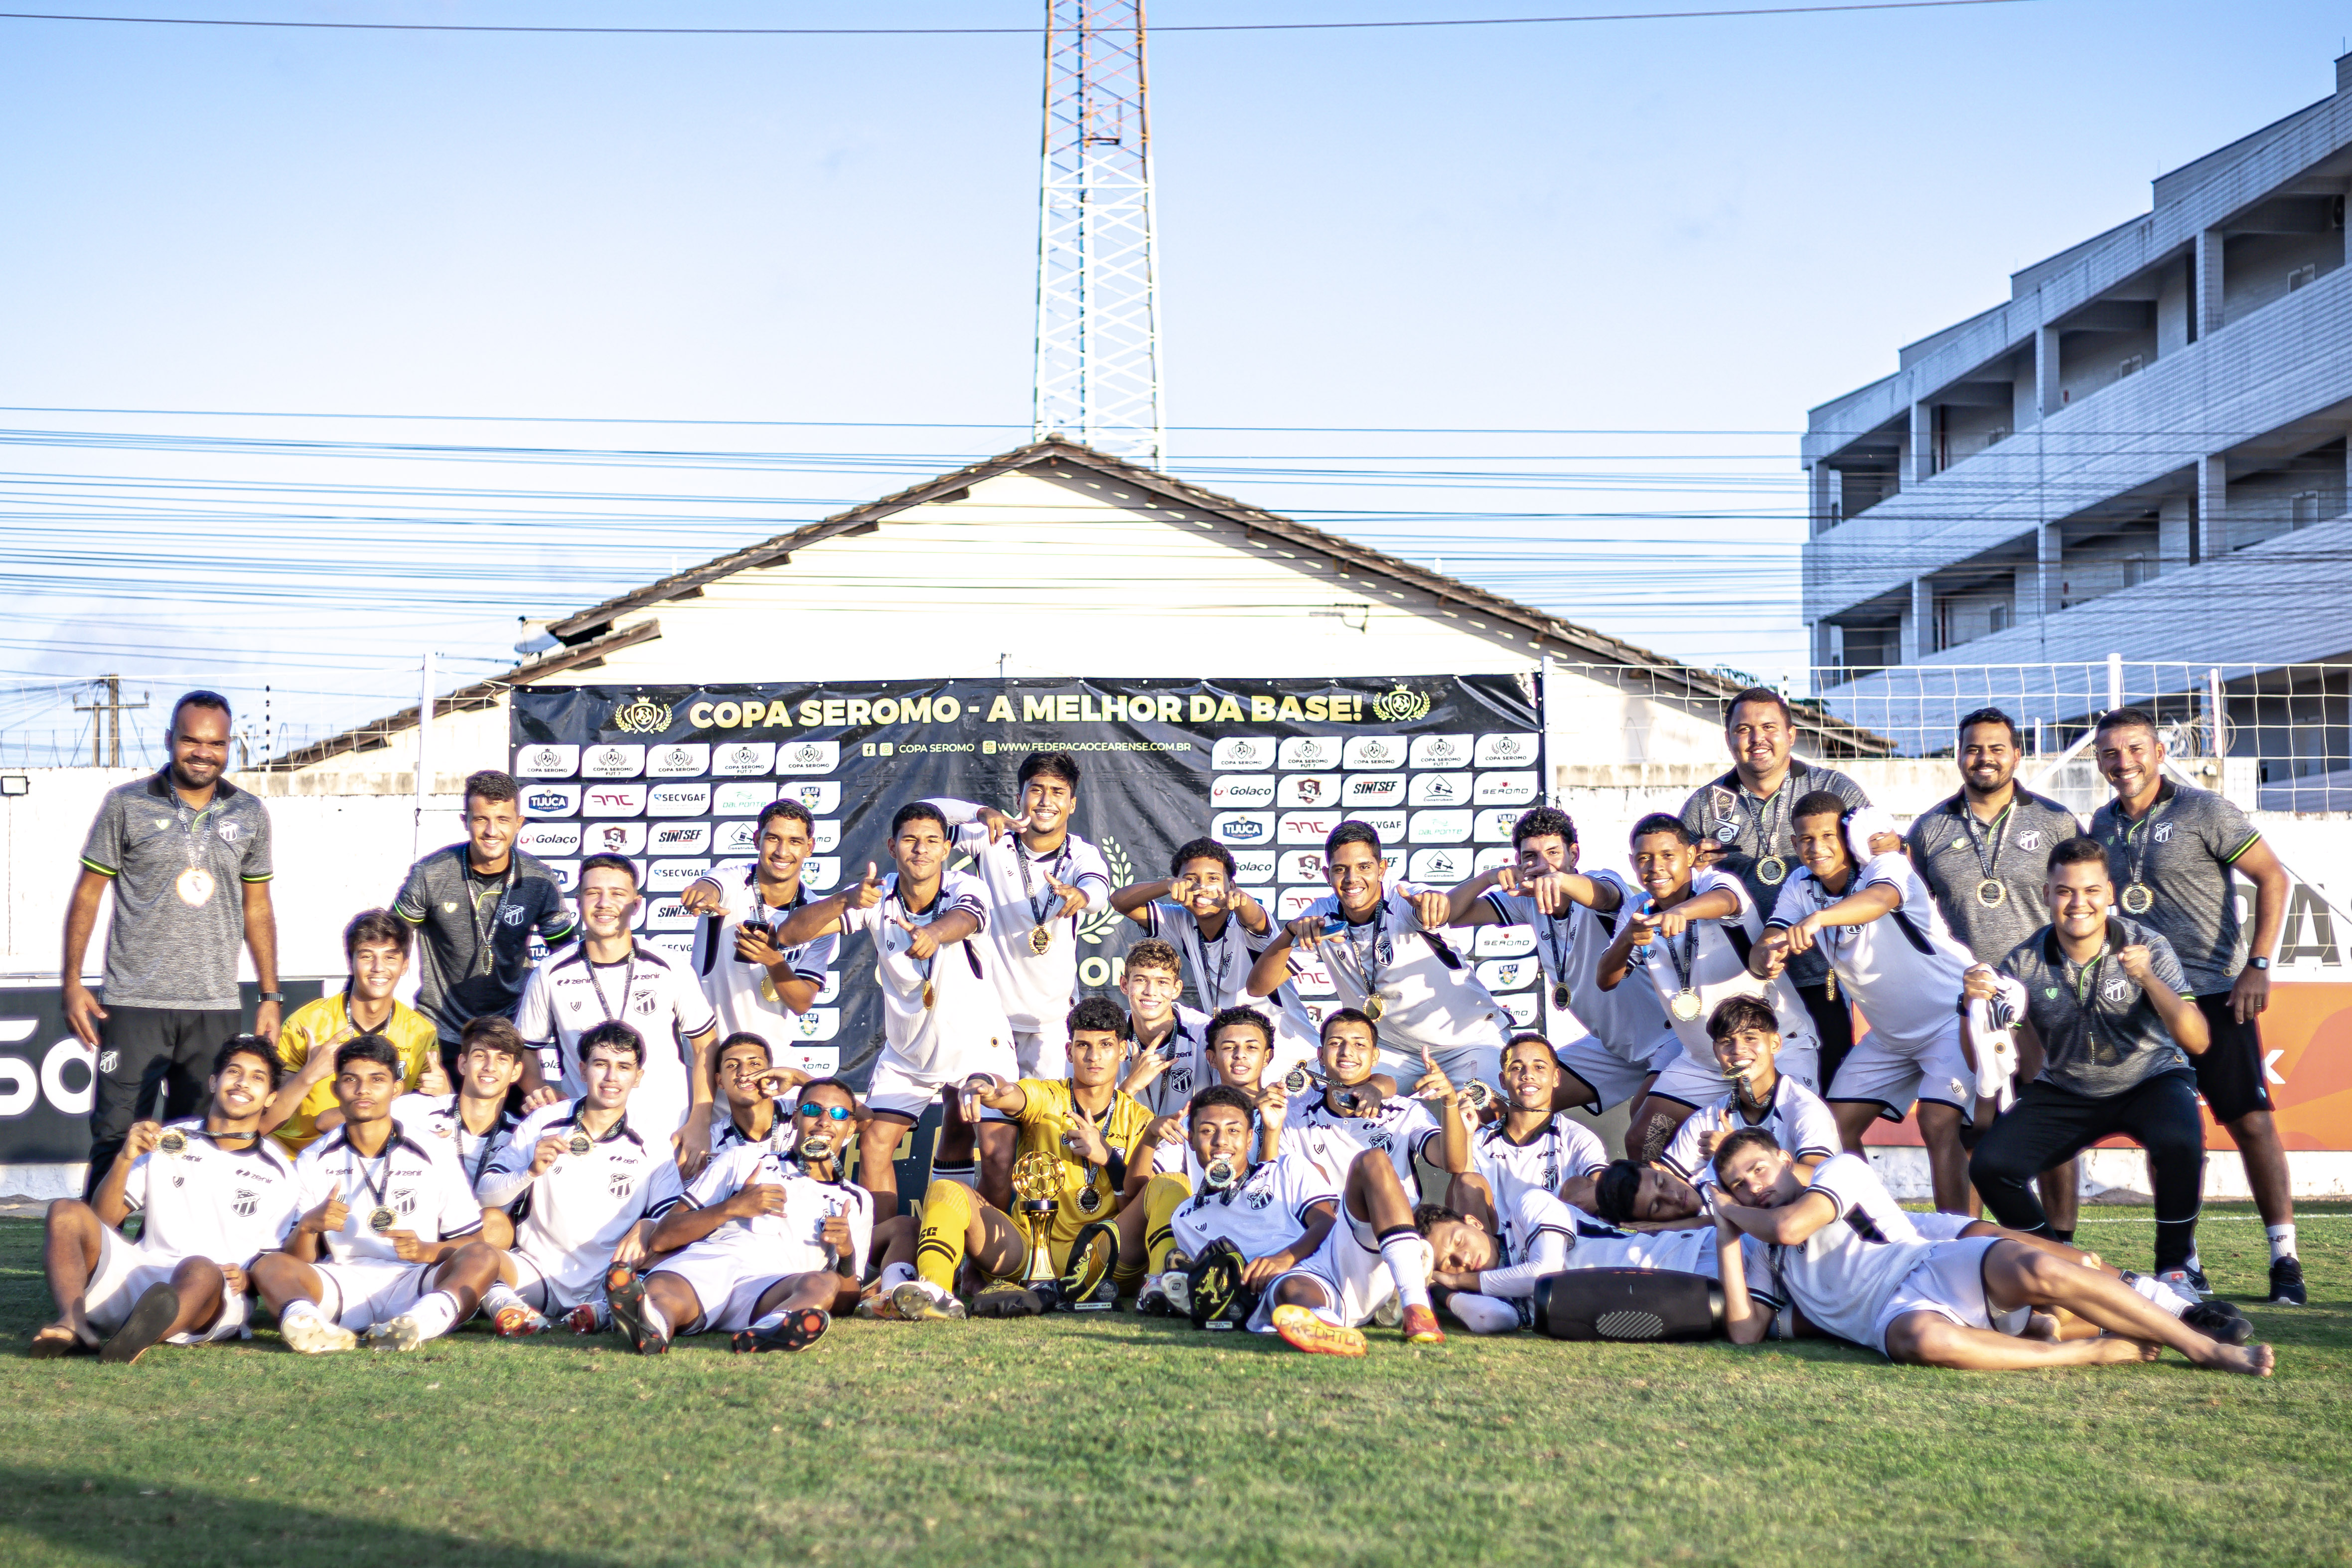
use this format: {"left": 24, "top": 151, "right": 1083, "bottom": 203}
{"left": 515, "top": 943, "right": 718, "bottom": 1138}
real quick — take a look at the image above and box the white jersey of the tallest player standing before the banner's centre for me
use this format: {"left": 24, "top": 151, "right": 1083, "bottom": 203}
{"left": 929, "top": 799, "right": 1110, "bottom": 1039}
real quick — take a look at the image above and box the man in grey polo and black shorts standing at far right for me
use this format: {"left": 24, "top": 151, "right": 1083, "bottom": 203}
{"left": 2091, "top": 708, "right": 2307, "bottom": 1307}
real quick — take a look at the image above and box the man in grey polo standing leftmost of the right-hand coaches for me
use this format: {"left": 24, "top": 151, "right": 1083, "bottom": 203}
{"left": 1682, "top": 687, "right": 1870, "bottom": 1086}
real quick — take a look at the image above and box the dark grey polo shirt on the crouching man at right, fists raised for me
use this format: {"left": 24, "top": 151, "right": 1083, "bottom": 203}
{"left": 1999, "top": 914, "right": 2190, "bottom": 1096}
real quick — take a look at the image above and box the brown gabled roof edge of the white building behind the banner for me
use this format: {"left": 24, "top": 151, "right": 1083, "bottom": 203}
{"left": 268, "top": 435, "right": 1894, "bottom": 769}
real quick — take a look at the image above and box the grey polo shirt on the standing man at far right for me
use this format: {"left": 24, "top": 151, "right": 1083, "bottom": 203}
{"left": 2091, "top": 778, "right": 2263, "bottom": 997}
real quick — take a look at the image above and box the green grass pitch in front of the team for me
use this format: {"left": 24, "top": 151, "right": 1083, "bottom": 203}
{"left": 0, "top": 1206, "right": 2352, "bottom": 1568}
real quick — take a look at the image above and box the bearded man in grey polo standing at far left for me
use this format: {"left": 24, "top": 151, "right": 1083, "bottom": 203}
{"left": 61, "top": 691, "right": 285, "bottom": 1197}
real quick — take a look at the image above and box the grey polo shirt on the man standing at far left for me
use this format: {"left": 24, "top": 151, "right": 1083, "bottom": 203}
{"left": 82, "top": 769, "right": 271, "bottom": 1013}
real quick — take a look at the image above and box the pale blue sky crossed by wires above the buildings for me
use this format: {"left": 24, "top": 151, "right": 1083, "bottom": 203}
{"left": 0, "top": 0, "right": 2348, "bottom": 762}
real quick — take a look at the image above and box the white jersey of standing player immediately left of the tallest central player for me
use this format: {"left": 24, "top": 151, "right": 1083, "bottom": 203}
{"left": 842, "top": 872, "right": 1014, "bottom": 1077}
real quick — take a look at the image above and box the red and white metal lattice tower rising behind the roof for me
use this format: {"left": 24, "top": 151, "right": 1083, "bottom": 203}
{"left": 1032, "top": 0, "right": 1167, "bottom": 468}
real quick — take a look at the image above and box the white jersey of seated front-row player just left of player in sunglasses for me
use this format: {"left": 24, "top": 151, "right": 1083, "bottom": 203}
{"left": 489, "top": 1100, "right": 685, "bottom": 1300}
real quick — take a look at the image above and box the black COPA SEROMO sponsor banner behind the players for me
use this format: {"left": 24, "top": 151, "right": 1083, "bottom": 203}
{"left": 513, "top": 675, "right": 1543, "bottom": 1081}
